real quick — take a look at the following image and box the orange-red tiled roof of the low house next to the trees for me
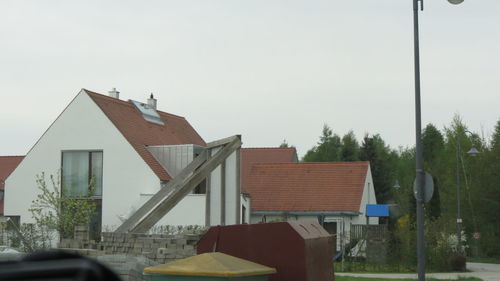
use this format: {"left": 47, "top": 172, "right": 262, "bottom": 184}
{"left": 247, "top": 162, "right": 369, "bottom": 212}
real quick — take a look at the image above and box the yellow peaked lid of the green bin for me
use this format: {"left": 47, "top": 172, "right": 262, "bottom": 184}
{"left": 144, "top": 252, "right": 276, "bottom": 277}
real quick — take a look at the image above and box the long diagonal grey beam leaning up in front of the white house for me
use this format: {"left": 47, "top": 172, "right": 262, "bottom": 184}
{"left": 115, "top": 136, "right": 241, "bottom": 233}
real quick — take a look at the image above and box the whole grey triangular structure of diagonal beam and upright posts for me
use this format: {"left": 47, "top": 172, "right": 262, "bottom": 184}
{"left": 115, "top": 135, "right": 241, "bottom": 233}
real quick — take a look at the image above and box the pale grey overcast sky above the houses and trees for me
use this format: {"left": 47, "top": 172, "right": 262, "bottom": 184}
{"left": 0, "top": 0, "right": 500, "bottom": 156}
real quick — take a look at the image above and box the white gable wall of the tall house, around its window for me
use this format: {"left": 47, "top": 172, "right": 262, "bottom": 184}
{"left": 5, "top": 91, "right": 160, "bottom": 228}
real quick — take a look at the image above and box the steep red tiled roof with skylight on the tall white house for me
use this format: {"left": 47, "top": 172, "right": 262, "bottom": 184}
{"left": 84, "top": 89, "right": 206, "bottom": 180}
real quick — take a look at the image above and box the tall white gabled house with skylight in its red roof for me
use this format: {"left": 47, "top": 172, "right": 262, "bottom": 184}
{"left": 5, "top": 89, "right": 246, "bottom": 236}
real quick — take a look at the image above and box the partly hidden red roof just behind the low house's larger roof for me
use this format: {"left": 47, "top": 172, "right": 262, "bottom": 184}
{"left": 241, "top": 147, "right": 297, "bottom": 193}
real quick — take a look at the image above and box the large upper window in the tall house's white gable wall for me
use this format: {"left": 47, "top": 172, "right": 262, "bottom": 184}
{"left": 61, "top": 151, "right": 102, "bottom": 198}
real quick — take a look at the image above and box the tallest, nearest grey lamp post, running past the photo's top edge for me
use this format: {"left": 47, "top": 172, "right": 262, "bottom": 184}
{"left": 413, "top": 0, "right": 463, "bottom": 281}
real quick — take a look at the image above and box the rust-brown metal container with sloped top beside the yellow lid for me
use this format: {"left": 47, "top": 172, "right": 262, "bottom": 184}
{"left": 197, "top": 221, "right": 334, "bottom": 281}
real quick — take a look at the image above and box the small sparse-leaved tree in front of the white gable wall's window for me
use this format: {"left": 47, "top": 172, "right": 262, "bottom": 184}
{"left": 29, "top": 173, "right": 96, "bottom": 238}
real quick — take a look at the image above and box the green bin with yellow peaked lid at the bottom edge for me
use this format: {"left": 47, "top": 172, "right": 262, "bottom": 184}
{"left": 144, "top": 252, "right": 276, "bottom": 281}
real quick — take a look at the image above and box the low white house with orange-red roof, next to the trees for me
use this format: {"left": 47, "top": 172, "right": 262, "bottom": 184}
{"left": 242, "top": 159, "right": 378, "bottom": 248}
